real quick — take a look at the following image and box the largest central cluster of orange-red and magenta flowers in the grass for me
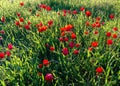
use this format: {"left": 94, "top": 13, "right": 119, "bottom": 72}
{"left": 59, "top": 24, "right": 80, "bottom": 56}
